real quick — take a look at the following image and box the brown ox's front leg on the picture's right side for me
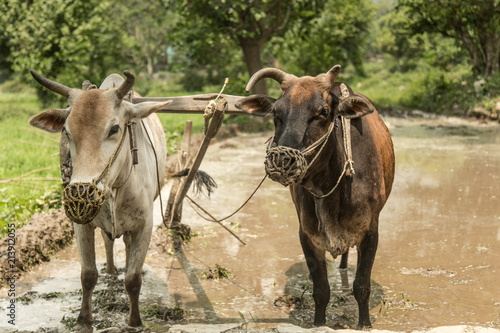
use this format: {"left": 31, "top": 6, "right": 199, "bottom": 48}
{"left": 353, "top": 231, "right": 378, "bottom": 328}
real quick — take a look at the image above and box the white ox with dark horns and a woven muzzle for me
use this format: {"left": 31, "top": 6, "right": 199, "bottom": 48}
{"left": 30, "top": 71, "right": 170, "bottom": 331}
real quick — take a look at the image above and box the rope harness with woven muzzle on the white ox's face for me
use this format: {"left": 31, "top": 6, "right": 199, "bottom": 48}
{"left": 63, "top": 121, "right": 138, "bottom": 224}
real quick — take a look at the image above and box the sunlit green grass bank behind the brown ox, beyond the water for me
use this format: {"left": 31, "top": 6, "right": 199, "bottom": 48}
{"left": 339, "top": 59, "right": 482, "bottom": 116}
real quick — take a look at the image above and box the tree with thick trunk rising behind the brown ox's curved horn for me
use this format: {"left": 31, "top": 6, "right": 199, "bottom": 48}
{"left": 170, "top": 0, "right": 324, "bottom": 94}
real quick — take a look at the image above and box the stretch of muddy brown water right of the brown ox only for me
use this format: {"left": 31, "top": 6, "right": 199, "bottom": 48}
{"left": 372, "top": 116, "right": 500, "bottom": 328}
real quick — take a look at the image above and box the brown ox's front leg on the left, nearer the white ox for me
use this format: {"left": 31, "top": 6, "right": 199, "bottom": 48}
{"left": 300, "top": 231, "right": 330, "bottom": 326}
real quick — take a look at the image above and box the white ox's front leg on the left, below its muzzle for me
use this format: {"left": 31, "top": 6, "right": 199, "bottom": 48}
{"left": 74, "top": 224, "right": 98, "bottom": 332}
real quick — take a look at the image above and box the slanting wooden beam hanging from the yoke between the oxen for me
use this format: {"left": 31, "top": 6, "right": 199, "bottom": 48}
{"left": 170, "top": 95, "right": 229, "bottom": 226}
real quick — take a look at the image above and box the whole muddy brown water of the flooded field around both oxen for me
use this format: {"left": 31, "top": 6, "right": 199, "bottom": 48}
{"left": 0, "top": 115, "right": 500, "bottom": 331}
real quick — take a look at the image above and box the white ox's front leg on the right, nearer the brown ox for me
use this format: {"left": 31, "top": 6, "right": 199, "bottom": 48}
{"left": 125, "top": 226, "right": 151, "bottom": 327}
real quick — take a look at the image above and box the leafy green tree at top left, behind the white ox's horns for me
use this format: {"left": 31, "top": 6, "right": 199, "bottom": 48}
{"left": 0, "top": 0, "right": 127, "bottom": 99}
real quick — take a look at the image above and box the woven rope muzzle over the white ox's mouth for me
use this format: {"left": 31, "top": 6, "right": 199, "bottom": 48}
{"left": 63, "top": 183, "right": 106, "bottom": 224}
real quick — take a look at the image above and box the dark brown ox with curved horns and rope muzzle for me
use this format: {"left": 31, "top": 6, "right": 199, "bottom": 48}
{"left": 239, "top": 65, "right": 394, "bottom": 328}
